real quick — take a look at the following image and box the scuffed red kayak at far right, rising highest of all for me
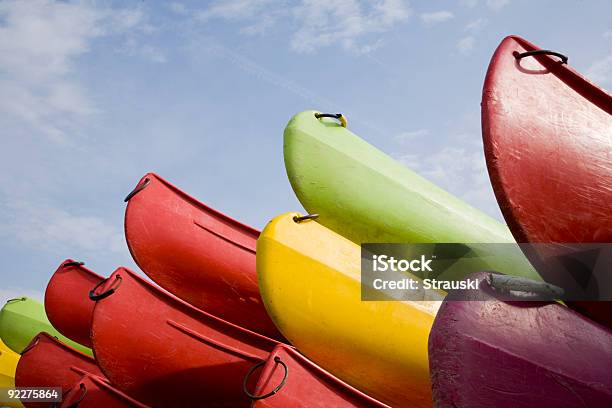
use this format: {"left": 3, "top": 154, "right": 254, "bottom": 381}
{"left": 482, "top": 36, "right": 612, "bottom": 327}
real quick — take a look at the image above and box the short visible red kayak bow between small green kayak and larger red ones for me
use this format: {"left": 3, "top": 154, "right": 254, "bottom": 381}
{"left": 45, "top": 259, "right": 104, "bottom": 347}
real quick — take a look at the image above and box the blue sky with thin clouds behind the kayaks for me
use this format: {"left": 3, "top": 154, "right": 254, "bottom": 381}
{"left": 0, "top": 0, "right": 612, "bottom": 301}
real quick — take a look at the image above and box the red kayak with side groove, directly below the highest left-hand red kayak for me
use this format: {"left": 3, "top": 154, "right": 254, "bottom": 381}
{"left": 91, "top": 268, "right": 278, "bottom": 407}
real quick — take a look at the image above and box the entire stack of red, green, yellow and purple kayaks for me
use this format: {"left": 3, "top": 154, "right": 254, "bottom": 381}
{"left": 5, "top": 33, "right": 612, "bottom": 408}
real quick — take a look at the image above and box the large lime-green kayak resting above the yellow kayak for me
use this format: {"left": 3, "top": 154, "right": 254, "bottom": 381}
{"left": 284, "top": 111, "right": 539, "bottom": 280}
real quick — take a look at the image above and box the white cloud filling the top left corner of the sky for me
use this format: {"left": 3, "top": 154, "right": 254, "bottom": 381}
{"left": 0, "top": 0, "right": 160, "bottom": 144}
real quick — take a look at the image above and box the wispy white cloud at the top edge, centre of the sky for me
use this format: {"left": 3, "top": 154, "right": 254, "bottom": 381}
{"left": 194, "top": 0, "right": 412, "bottom": 53}
